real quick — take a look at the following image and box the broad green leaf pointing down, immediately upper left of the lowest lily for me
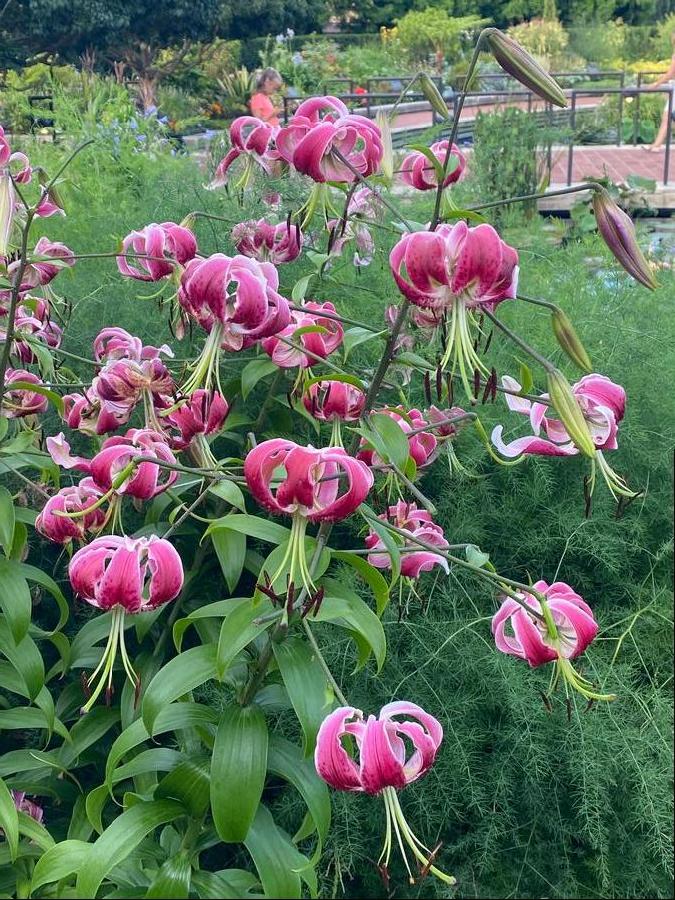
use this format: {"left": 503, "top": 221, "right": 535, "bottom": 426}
{"left": 274, "top": 636, "right": 333, "bottom": 756}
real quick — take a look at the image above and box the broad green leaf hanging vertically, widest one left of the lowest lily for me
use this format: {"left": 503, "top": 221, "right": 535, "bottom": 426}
{"left": 211, "top": 704, "right": 268, "bottom": 843}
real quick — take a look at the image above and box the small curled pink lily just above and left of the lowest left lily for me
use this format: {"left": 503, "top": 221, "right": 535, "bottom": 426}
{"left": 35, "top": 477, "right": 108, "bottom": 544}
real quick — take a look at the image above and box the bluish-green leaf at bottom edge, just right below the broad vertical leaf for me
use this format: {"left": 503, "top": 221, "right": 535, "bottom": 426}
{"left": 244, "top": 804, "right": 316, "bottom": 900}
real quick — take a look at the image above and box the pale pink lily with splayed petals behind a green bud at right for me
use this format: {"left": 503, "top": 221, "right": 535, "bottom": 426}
{"left": 492, "top": 374, "right": 638, "bottom": 501}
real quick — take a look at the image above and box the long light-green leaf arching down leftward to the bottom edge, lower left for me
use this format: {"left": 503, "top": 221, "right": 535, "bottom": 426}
{"left": 75, "top": 800, "right": 184, "bottom": 897}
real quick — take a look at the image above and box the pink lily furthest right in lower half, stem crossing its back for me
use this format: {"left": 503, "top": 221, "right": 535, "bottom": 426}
{"left": 492, "top": 581, "right": 614, "bottom": 700}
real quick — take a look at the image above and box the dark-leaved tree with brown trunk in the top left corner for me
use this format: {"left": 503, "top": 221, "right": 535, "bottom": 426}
{"left": 3, "top": 0, "right": 221, "bottom": 109}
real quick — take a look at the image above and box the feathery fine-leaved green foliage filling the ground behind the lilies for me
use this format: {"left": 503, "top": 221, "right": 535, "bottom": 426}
{"left": 18, "top": 135, "right": 675, "bottom": 898}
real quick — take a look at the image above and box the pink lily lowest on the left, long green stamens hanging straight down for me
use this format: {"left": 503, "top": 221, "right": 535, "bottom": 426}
{"left": 68, "top": 535, "right": 183, "bottom": 713}
